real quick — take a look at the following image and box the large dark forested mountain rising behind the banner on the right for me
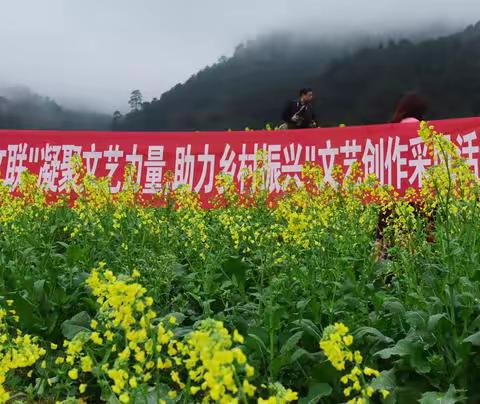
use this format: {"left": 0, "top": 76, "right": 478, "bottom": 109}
{"left": 115, "top": 23, "right": 480, "bottom": 130}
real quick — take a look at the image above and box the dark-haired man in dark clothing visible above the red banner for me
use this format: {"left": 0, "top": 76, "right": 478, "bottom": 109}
{"left": 282, "top": 88, "right": 317, "bottom": 129}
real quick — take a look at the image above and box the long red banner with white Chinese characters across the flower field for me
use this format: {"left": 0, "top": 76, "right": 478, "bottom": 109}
{"left": 0, "top": 118, "right": 480, "bottom": 197}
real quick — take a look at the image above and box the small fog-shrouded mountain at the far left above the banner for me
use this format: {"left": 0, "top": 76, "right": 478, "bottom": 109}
{"left": 0, "top": 86, "right": 111, "bottom": 130}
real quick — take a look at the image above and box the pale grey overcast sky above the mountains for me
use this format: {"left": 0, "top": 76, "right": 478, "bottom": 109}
{"left": 0, "top": 0, "right": 480, "bottom": 112}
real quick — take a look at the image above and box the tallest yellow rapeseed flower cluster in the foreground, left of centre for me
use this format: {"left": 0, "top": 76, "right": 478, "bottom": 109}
{"left": 57, "top": 263, "right": 179, "bottom": 403}
